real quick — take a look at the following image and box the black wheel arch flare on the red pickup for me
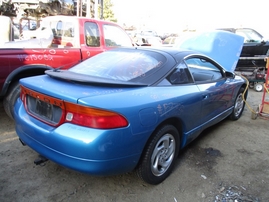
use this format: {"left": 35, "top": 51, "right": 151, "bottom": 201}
{"left": 0, "top": 64, "right": 53, "bottom": 97}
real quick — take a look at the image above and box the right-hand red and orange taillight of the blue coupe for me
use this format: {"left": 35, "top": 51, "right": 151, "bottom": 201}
{"left": 64, "top": 102, "right": 128, "bottom": 129}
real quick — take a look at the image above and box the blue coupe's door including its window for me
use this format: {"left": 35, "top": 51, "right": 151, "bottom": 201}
{"left": 185, "top": 56, "right": 232, "bottom": 128}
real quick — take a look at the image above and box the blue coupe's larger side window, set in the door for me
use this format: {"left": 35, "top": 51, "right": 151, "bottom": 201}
{"left": 185, "top": 57, "right": 223, "bottom": 82}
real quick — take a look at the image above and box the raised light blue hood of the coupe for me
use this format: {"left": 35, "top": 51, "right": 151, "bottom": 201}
{"left": 175, "top": 30, "right": 244, "bottom": 72}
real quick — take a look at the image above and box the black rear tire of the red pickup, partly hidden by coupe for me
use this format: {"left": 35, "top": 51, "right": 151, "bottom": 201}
{"left": 3, "top": 81, "right": 21, "bottom": 120}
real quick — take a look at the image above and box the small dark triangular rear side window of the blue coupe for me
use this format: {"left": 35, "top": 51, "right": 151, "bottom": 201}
{"left": 168, "top": 62, "right": 193, "bottom": 84}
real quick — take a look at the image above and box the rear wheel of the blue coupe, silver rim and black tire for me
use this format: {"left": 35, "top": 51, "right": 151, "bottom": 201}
{"left": 136, "top": 125, "right": 180, "bottom": 185}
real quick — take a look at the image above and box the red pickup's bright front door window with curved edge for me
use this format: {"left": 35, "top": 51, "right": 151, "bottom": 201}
{"left": 104, "top": 25, "right": 132, "bottom": 46}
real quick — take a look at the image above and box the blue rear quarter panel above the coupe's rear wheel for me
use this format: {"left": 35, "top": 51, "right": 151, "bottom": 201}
{"left": 79, "top": 85, "right": 202, "bottom": 151}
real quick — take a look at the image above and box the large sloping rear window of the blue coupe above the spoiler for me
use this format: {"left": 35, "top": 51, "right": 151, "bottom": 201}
{"left": 69, "top": 49, "right": 165, "bottom": 81}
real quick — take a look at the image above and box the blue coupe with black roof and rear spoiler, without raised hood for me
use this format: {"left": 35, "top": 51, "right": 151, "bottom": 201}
{"left": 15, "top": 40, "right": 247, "bottom": 184}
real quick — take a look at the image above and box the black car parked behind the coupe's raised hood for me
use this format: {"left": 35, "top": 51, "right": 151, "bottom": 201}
{"left": 218, "top": 28, "right": 269, "bottom": 71}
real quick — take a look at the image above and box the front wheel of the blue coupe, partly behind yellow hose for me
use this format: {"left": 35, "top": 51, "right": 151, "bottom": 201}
{"left": 229, "top": 87, "right": 247, "bottom": 121}
